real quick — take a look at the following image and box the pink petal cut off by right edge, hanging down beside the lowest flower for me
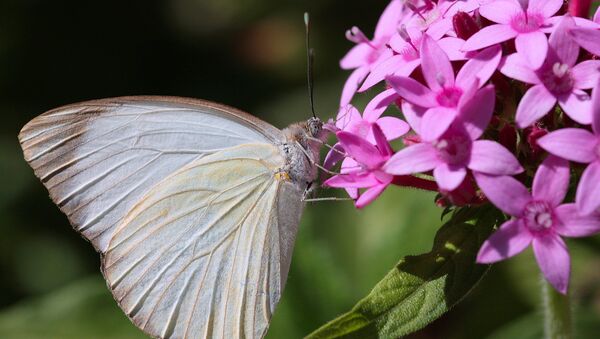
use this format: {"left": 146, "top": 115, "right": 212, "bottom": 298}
{"left": 575, "top": 161, "right": 600, "bottom": 215}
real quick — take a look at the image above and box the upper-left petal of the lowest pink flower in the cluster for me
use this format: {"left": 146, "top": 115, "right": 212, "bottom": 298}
{"left": 473, "top": 172, "right": 532, "bottom": 217}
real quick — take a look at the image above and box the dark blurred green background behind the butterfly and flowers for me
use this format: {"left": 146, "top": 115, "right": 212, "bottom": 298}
{"left": 0, "top": 0, "right": 600, "bottom": 338}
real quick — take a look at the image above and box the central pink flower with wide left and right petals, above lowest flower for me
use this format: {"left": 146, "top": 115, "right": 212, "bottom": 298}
{"left": 383, "top": 85, "right": 523, "bottom": 191}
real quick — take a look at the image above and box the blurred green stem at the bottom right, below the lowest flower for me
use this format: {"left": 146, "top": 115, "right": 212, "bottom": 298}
{"left": 542, "top": 277, "right": 573, "bottom": 339}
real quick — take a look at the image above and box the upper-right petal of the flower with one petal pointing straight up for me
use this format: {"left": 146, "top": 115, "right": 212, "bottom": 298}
{"left": 456, "top": 45, "right": 502, "bottom": 87}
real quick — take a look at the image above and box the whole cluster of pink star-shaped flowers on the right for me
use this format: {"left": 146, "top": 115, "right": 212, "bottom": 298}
{"left": 324, "top": 0, "right": 600, "bottom": 293}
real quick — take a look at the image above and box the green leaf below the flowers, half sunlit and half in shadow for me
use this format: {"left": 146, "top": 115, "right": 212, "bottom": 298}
{"left": 307, "top": 207, "right": 503, "bottom": 339}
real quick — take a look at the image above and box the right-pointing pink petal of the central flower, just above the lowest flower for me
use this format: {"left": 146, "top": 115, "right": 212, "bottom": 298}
{"left": 467, "top": 140, "right": 523, "bottom": 175}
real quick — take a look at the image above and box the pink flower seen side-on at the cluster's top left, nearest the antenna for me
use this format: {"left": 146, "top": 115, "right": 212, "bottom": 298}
{"left": 340, "top": 0, "right": 407, "bottom": 107}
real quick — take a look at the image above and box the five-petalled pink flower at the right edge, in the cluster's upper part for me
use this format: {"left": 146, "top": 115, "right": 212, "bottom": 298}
{"left": 500, "top": 17, "right": 600, "bottom": 128}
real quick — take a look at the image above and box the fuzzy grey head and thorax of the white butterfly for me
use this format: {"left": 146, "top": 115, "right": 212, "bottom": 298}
{"left": 282, "top": 118, "right": 325, "bottom": 187}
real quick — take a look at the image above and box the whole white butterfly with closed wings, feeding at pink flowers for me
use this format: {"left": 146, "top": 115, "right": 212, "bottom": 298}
{"left": 19, "top": 97, "right": 322, "bottom": 338}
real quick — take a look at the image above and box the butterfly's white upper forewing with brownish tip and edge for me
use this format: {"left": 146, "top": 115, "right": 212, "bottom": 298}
{"left": 19, "top": 97, "right": 285, "bottom": 253}
